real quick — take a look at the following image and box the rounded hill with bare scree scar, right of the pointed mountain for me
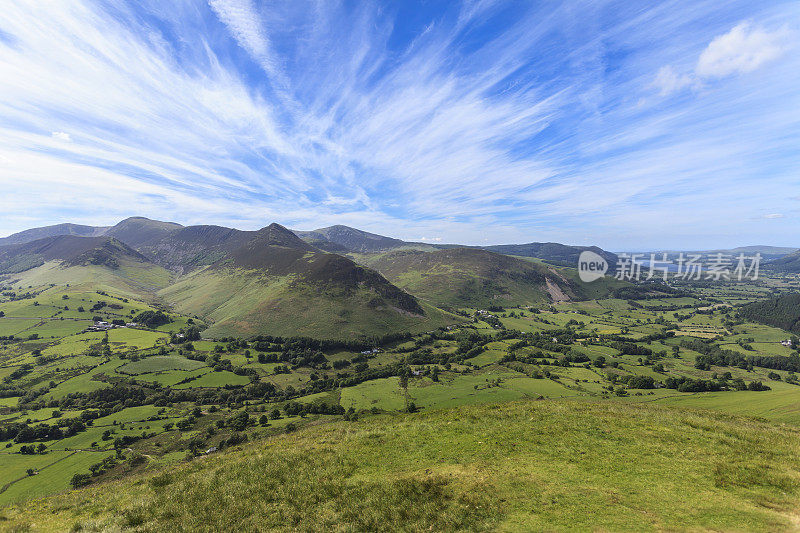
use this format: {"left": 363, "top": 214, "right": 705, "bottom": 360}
{"left": 368, "top": 248, "right": 575, "bottom": 308}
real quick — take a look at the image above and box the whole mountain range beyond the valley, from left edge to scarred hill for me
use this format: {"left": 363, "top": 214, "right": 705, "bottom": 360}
{"left": 0, "top": 217, "right": 636, "bottom": 338}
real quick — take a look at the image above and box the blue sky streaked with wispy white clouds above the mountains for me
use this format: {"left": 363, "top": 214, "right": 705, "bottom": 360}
{"left": 0, "top": 0, "right": 800, "bottom": 250}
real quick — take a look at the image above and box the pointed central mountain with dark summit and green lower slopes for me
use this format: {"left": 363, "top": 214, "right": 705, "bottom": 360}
{"left": 160, "top": 224, "right": 457, "bottom": 338}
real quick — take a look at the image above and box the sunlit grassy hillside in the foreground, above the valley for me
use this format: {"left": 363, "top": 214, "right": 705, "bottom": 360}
{"left": 0, "top": 400, "right": 800, "bottom": 531}
